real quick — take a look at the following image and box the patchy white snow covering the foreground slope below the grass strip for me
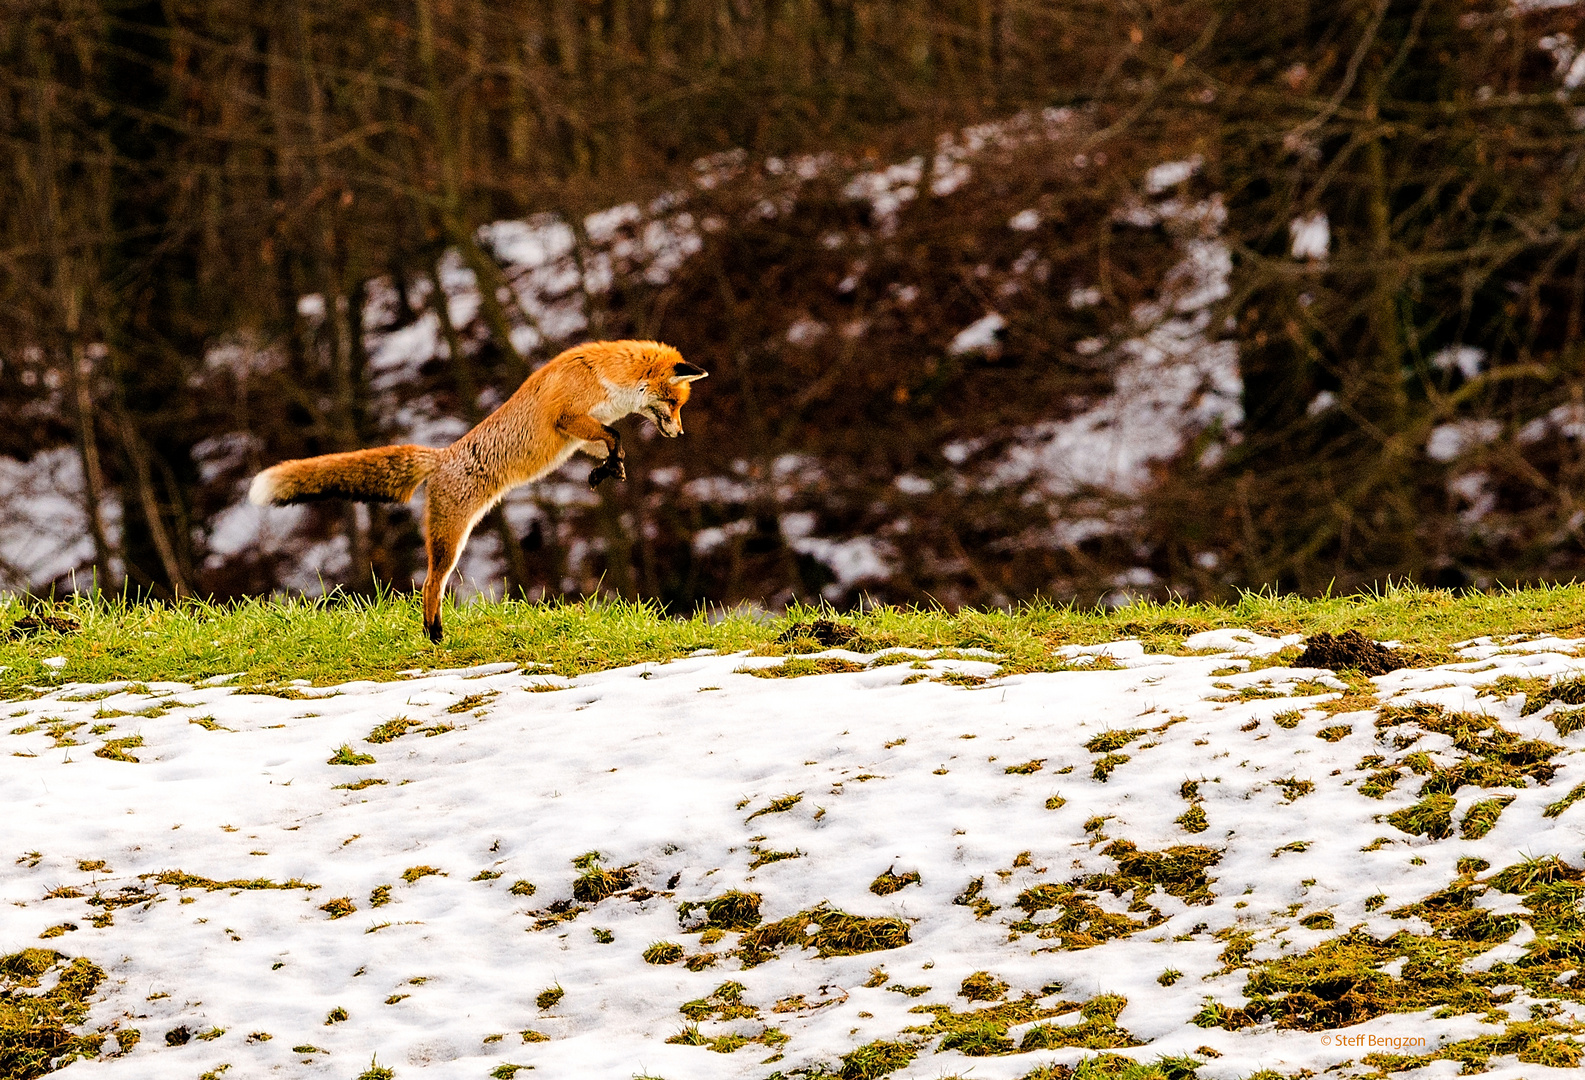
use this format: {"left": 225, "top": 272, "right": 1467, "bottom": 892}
{"left": 9, "top": 631, "right": 1585, "bottom": 1080}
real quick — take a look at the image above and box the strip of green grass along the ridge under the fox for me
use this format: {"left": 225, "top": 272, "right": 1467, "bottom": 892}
{"left": 0, "top": 585, "right": 1585, "bottom": 698}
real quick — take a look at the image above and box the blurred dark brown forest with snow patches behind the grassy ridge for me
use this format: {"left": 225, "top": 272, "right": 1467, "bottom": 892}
{"left": 0, "top": 0, "right": 1585, "bottom": 611}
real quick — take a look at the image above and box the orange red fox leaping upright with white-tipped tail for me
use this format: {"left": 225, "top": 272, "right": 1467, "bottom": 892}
{"left": 247, "top": 341, "right": 708, "bottom": 642}
